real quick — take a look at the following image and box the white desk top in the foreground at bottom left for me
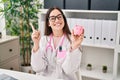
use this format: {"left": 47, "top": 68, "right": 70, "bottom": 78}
{"left": 0, "top": 69, "right": 62, "bottom": 80}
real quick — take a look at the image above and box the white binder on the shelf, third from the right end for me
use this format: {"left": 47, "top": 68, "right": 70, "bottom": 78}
{"left": 94, "top": 20, "right": 102, "bottom": 44}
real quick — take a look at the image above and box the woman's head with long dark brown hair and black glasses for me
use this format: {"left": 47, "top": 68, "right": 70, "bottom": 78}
{"left": 44, "top": 7, "right": 71, "bottom": 36}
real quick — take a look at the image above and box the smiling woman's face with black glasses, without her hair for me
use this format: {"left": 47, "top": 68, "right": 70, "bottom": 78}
{"left": 48, "top": 9, "right": 65, "bottom": 32}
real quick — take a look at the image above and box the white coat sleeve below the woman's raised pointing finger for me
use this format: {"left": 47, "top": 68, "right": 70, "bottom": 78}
{"left": 31, "top": 38, "right": 47, "bottom": 73}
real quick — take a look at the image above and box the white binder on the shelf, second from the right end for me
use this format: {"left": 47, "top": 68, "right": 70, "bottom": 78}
{"left": 101, "top": 20, "right": 110, "bottom": 45}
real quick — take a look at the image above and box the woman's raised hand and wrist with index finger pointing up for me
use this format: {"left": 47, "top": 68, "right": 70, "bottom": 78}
{"left": 30, "top": 24, "right": 41, "bottom": 52}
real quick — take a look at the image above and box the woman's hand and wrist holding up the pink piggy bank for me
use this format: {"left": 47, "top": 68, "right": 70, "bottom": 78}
{"left": 71, "top": 30, "right": 84, "bottom": 50}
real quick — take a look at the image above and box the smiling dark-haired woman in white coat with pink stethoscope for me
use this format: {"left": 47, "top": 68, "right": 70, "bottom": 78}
{"left": 31, "top": 7, "right": 84, "bottom": 80}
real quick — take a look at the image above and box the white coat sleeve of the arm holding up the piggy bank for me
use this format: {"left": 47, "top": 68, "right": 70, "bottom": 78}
{"left": 62, "top": 48, "right": 82, "bottom": 75}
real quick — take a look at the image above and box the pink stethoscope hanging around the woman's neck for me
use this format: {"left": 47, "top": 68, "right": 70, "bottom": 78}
{"left": 46, "top": 34, "right": 65, "bottom": 52}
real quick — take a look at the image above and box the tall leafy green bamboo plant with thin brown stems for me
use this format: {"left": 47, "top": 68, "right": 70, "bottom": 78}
{"left": 0, "top": 0, "right": 42, "bottom": 73}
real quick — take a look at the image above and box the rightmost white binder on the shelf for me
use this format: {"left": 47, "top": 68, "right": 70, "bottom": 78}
{"left": 108, "top": 20, "right": 117, "bottom": 46}
